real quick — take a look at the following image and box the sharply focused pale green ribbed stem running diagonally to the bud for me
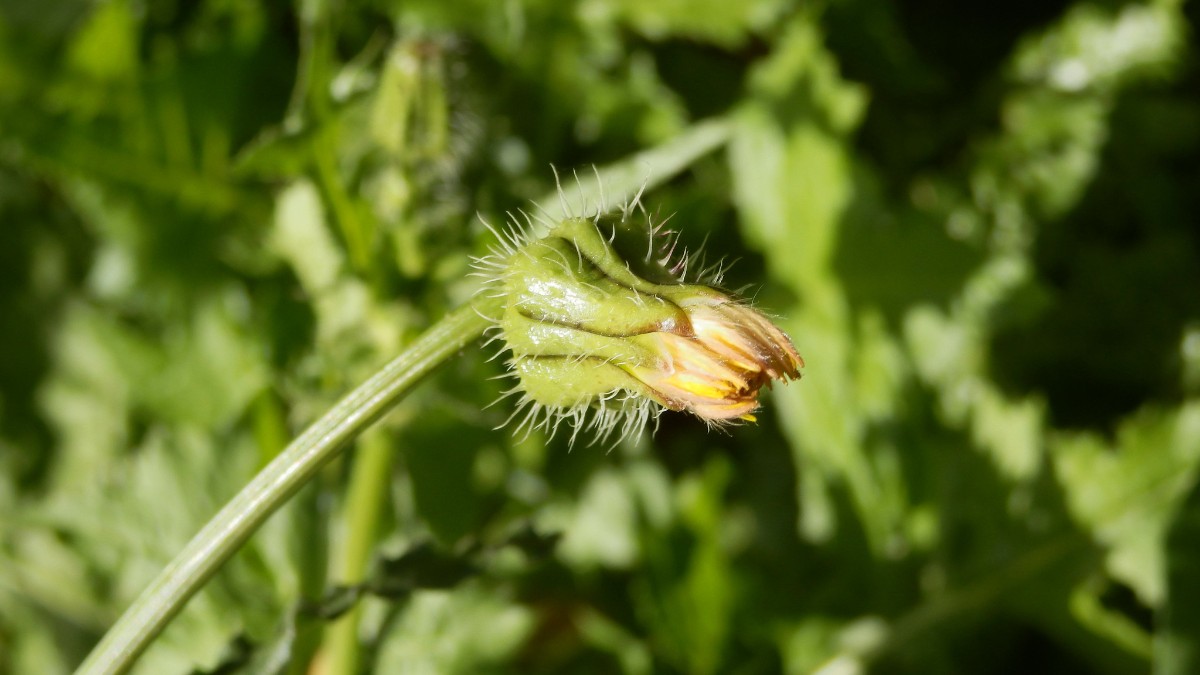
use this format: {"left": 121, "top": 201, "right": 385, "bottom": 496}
{"left": 77, "top": 297, "right": 498, "bottom": 675}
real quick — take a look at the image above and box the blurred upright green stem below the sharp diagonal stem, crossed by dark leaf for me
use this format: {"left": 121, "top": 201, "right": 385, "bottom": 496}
{"left": 325, "top": 425, "right": 395, "bottom": 673}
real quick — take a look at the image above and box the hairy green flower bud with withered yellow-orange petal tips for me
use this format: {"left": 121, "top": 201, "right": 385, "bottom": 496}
{"left": 478, "top": 193, "right": 804, "bottom": 440}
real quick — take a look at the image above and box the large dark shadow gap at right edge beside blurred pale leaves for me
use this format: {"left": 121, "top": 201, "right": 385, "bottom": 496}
{"left": 991, "top": 82, "right": 1200, "bottom": 429}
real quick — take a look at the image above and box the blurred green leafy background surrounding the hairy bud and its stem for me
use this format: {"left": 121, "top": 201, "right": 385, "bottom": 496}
{"left": 0, "top": 0, "right": 1200, "bottom": 675}
